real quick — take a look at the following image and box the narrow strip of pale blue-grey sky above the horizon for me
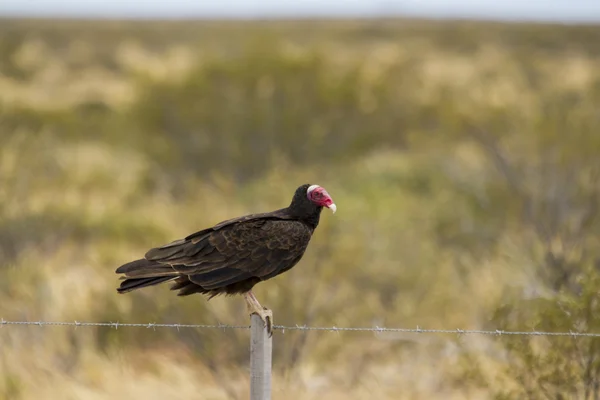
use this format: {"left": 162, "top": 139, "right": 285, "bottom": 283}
{"left": 0, "top": 0, "right": 600, "bottom": 22}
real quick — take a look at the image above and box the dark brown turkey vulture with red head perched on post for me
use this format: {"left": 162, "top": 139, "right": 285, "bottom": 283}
{"left": 116, "top": 184, "right": 336, "bottom": 335}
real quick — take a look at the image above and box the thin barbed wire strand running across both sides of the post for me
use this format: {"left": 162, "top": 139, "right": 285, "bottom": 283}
{"left": 0, "top": 318, "right": 600, "bottom": 337}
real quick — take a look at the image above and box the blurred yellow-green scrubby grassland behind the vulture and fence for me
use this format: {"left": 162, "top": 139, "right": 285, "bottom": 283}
{"left": 0, "top": 20, "right": 600, "bottom": 400}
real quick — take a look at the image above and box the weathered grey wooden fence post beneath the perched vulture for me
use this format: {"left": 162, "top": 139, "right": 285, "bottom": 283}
{"left": 250, "top": 314, "right": 273, "bottom": 400}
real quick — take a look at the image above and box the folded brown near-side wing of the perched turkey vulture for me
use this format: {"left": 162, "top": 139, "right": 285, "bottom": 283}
{"left": 146, "top": 217, "right": 312, "bottom": 290}
